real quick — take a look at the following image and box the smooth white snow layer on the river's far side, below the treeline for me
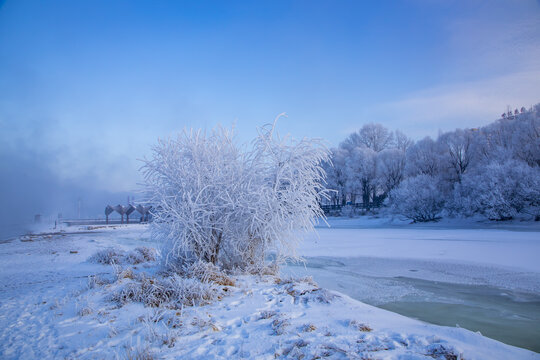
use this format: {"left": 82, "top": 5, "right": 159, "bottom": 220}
{"left": 300, "top": 217, "right": 540, "bottom": 272}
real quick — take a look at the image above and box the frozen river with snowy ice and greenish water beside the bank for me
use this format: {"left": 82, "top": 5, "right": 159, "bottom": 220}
{"left": 285, "top": 219, "right": 540, "bottom": 352}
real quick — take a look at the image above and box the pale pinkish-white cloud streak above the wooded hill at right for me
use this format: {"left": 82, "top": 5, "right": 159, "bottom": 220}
{"left": 371, "top": 70, "right": 540, "bottom": 138}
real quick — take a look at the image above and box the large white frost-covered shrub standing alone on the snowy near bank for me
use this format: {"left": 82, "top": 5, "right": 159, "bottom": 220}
{"left": 143, "top": 119, "right": 328, "bottom": 271}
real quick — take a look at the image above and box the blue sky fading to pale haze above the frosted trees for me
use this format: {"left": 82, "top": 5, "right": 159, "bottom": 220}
{"left": 0, "top": 0, "right": 540, "bottom": 225}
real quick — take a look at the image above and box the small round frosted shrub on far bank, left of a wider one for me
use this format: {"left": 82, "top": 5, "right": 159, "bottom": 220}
{"left": 389, "top": 175, "right": 444, "bottom": 222}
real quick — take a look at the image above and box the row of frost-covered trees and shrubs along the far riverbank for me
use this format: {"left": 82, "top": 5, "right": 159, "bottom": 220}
{"left": 324, "top": 104, "right": 540, "bottom": 221}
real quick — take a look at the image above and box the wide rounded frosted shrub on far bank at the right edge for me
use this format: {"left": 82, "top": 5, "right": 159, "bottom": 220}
{"left": 452, "top": 160, "right": 540, "bottom": 220}
